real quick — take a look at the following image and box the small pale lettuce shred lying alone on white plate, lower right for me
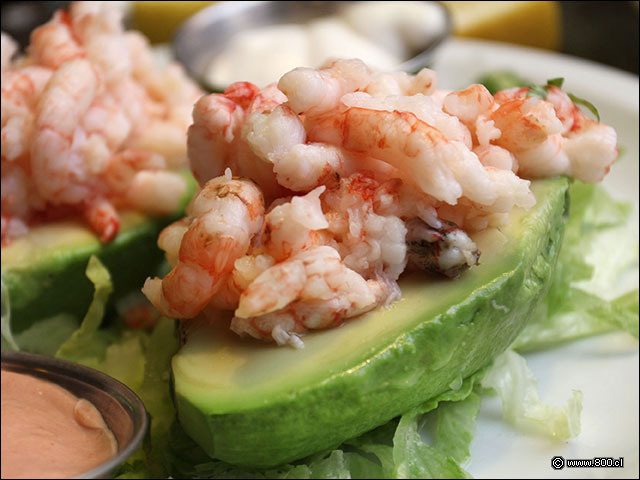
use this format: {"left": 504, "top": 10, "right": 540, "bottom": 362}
{"left": 481, "top": 350, "right": 582, "bottom": 440}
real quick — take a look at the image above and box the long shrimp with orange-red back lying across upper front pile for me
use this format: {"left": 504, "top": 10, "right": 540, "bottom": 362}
{"left": 308, "top": 107, "right": 533, "bottom": 213}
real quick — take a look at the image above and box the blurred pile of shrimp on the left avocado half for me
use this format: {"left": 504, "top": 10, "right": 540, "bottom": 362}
{"left": 2, "top": 2, "right": 201, "bottom": 245}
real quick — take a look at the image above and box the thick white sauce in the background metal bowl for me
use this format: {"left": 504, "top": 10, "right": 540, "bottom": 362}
{"left": 205, "top": 2, "right": 445, "bottom": 88}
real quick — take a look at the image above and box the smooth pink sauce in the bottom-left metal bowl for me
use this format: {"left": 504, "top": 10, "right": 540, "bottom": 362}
{"left": 1, "top": 370, "right": 118, "bottom": 478}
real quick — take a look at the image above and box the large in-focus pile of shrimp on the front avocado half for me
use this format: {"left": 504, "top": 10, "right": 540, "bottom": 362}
{"left": 143, "top": 60, "right": 617, "bottom": 347}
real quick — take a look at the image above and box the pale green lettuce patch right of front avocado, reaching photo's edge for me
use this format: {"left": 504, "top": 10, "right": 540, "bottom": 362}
{"left": 512, "top": 182, "right": 638, "bottom": 352}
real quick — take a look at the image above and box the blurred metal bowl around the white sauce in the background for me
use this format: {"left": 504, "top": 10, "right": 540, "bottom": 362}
{"left": 172, "top": 1, "right": 451, "bottom": 92}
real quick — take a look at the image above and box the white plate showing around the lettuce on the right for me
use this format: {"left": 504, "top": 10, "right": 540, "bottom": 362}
{"left": 433, "top": 40, "right": 638, "bottom": 478}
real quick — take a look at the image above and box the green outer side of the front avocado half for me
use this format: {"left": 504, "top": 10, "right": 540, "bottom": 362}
{"left": 173, "top": 178, "right": 568, "bottom": 468}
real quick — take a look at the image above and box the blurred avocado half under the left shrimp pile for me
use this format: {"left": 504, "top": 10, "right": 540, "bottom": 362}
{"left": 2, "top": 172, "right": 196, "bottom": 333}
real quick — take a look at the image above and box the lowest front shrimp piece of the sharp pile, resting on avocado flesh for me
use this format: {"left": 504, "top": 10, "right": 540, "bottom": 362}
{"left": 231, "top": 246, "right": 389, "bottom": 348}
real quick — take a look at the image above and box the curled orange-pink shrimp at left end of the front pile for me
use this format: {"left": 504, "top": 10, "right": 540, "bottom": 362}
{"left": 142, "top": 175, "right": 264, "bottom": 318}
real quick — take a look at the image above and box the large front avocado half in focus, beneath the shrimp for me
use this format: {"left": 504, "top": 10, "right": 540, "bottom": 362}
{"left": 172, "top": 178, "right": 568, "bottom": 468}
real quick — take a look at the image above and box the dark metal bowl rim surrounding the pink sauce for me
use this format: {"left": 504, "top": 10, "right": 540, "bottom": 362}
{"left": 2, "top": 351, "right": 149, "bottom": 478}
